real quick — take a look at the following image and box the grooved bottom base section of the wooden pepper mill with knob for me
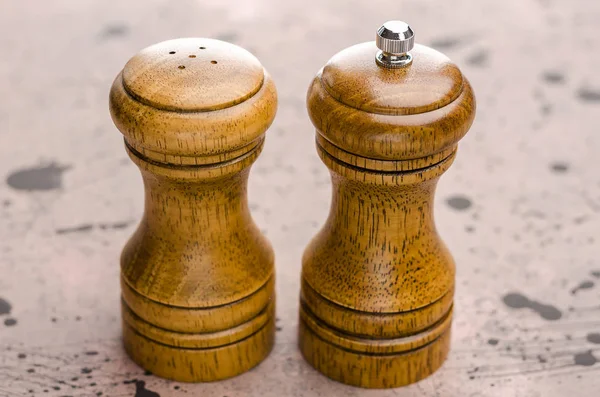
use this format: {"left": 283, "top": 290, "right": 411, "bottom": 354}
{"left": 299, "top": 307, "right": 452, "bottom": 389}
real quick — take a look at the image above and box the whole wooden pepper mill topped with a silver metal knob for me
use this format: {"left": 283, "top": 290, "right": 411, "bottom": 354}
{"left": 299, "top": 21, "right": 475, "bottom": 388}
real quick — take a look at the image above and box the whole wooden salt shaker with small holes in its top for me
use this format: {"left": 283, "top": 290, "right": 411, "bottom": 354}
{"left": 110, "top": 38, "right": 277, "bottom": 382}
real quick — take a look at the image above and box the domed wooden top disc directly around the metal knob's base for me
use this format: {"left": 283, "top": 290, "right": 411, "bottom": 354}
{"left": 320, "top": 41, "right": 463, "bottom": 115}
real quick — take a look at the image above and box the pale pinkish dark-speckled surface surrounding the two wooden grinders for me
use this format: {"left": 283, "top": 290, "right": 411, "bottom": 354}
{"left": 0, "top": 0, "right": 600, "bottom": 397}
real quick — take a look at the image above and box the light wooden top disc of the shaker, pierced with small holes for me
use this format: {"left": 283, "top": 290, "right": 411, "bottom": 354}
{"left": 122, "top": 39, "right": 264, "bottom": 112}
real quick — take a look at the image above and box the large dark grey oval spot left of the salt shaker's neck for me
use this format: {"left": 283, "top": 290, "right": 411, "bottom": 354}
{"left": 6, "top": 163, "right": 70, "bottom": 191}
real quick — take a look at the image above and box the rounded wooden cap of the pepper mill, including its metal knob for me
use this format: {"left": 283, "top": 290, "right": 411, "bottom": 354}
{"left": 307, "top": 21, "right": 475, "bottom": 168}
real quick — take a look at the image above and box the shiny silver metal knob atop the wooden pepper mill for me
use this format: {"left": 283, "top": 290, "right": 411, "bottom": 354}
{"left": 375, "top": 21, "right": 415, "bottom": 68}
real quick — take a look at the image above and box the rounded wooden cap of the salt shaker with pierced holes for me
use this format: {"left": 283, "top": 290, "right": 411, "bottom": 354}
{"left": 110, "top": 38, "right": 277, "bottom": 165}
